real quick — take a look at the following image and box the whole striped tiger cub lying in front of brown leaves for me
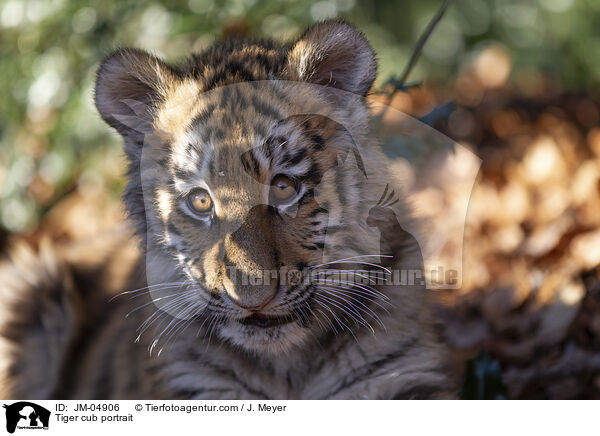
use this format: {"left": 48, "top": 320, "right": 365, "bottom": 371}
{"left": 0, "top": 20, "right": 455, "bottom": 399}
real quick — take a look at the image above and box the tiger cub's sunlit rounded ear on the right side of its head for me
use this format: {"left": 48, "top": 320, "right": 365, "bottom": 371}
{"left": 288, "top": 20, "right": 377, "bottom": 96}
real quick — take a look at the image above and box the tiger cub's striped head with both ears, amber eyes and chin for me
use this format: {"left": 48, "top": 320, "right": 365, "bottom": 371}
{"left": 95, "top": 21, "right": 384, "bottom": 352}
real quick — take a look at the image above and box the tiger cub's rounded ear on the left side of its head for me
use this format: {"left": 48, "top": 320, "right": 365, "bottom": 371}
{"left": 94, "top": 49, "right": 178, "bottom": 136}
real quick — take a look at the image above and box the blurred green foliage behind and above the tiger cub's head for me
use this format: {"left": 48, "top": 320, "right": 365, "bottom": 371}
{"left": 0, "top": 0, "right": 600, "bottom": 233}
